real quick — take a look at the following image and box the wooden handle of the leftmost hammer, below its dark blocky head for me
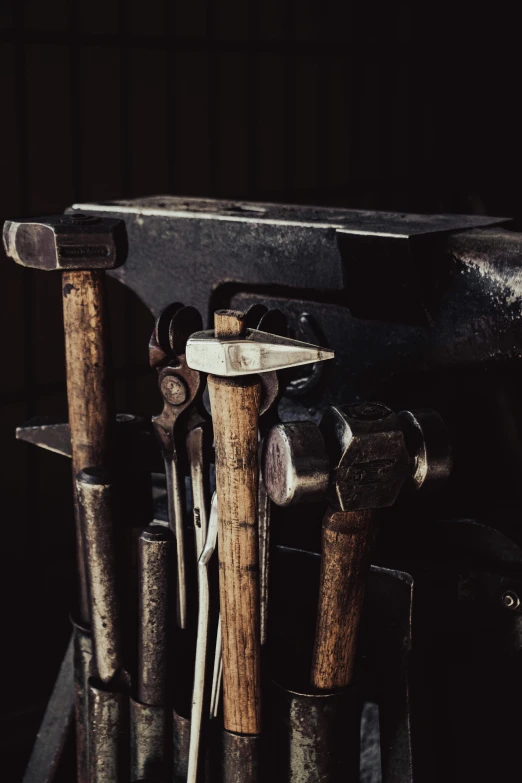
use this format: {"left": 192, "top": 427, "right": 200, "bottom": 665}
{"left": 62, "top": 270, "right": 112, "bottom": 623}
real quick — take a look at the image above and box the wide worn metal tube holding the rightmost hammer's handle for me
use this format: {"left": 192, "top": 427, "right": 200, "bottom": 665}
{"left": 268, "top": 685, "right": 360, "bottom": 783}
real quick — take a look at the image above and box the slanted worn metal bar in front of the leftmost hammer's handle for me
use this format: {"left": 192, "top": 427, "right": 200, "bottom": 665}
{"left": 77, "top": 468, "right": 122, "bottom": 683}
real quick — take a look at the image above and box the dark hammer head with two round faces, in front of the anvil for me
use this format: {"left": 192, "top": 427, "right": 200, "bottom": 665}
{"left": 263, "top": 402, "right": 451, "bottom": 511}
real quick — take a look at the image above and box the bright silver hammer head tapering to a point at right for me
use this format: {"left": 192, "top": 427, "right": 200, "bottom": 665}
{"left": 186, "top": 329, "right": 334, "bottom": 378}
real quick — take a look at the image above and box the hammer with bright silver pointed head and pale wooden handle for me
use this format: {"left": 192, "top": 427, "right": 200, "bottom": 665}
{"left": 186, "top": 310, "right": 333, "bottom": 735}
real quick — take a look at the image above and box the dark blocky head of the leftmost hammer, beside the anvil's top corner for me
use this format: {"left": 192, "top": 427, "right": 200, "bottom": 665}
{"left": 3, "top": 213, "right": 127, "bottom": 271}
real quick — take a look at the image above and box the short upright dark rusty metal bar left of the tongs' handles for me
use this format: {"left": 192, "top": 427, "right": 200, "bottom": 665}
{"left": 138, "top": 525, "right": 174, "bottom": 706}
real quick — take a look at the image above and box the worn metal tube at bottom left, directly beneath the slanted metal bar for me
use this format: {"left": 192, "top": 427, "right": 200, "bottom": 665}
{"left": 89, "top": 678, "right": 129, "bottom": 783}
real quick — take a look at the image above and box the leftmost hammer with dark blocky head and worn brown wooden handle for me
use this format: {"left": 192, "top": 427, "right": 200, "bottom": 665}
{"left": 3, "top": 213, "right": 127, "bottom": 624}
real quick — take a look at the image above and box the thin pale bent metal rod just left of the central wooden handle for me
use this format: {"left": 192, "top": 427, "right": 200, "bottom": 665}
{"left": 187, "top": 494, "right": 218, "bottom": 783}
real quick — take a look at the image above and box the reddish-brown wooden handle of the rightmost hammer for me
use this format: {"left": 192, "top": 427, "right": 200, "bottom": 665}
{"left": 312, "top": 510, "right": 376, "bottom": 690}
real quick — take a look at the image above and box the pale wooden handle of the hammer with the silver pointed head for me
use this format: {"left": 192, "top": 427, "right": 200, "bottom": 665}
{"left": 208, "top": 311, "right": 261, "bottom": 734}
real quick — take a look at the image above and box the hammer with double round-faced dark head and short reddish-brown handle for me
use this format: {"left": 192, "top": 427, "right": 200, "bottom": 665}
{"left": 263, "top": 402, "right": 451, "bottom": 690}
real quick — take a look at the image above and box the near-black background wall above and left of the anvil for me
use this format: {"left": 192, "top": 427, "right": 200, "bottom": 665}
{"left": 0, "top": 0, "right": 522, "bottom": 781}
